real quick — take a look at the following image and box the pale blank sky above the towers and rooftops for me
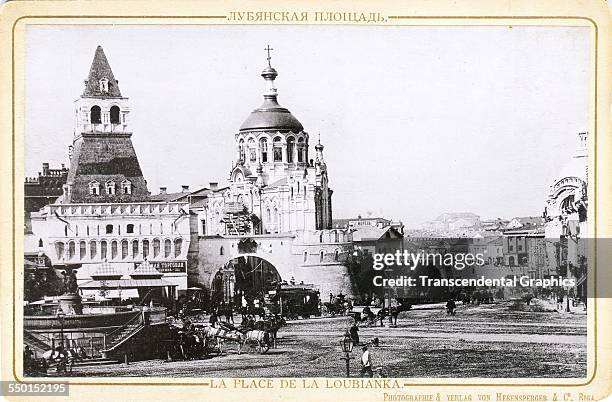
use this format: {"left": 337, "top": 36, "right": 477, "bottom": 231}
{"left": 26, "top": 26, "right": 590, "bottom": 226}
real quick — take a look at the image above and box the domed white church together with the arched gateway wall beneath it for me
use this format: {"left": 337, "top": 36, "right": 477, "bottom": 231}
{"left": 190, "top": 47, "right": 353, "bottom": 295}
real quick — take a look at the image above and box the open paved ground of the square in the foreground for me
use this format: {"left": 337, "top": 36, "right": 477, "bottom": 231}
{"left": 74, "top": 303, "right": 587, "bottom": 378}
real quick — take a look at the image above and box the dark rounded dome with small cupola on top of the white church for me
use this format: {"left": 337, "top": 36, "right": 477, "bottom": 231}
{"left": 240, "top": 47, "right": 304, "bottom": 133}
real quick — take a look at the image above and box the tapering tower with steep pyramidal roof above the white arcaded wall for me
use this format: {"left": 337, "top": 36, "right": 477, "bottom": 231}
{"left": 64, "top": 46, "right": 149, "bottom": 203}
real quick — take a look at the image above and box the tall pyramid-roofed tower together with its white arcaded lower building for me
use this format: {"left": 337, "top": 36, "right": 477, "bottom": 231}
{"left": 31, "top": 46, "right": 190, "bottom": 297}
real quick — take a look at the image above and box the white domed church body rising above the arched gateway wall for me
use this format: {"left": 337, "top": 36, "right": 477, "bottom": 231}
{"left": 228, "top": 46, "right": 332, "bottom": 233}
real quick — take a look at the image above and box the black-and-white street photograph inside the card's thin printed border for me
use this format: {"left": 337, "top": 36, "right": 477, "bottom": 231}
{"left": 16, "top": 21, "right": 594, "bottom": 380}
